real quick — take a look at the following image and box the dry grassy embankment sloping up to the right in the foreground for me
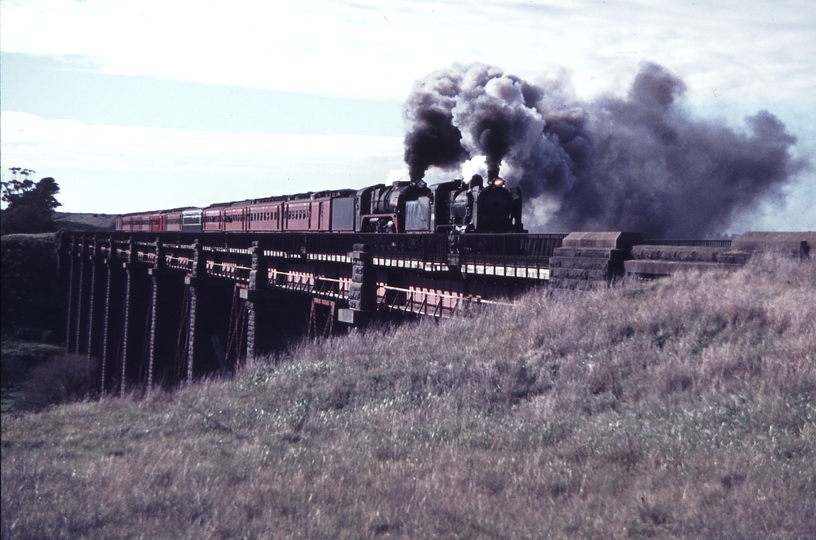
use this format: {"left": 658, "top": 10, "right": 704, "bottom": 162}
{"left": 2, "top": 254, "right": 816, "bottom": 539}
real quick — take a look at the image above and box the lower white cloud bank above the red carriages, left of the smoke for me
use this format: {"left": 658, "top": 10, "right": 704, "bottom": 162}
{"left": 0, "top": 112, "right": 402, "bottom": 213}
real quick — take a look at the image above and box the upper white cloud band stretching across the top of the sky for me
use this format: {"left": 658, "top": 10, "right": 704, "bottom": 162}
{"left": 2, "top": 0, "right": 816, "bottom": 104}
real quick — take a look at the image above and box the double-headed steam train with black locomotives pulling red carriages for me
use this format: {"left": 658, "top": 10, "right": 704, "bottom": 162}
{"left": 116, "top": 171, "right": 524, "bottom": 234}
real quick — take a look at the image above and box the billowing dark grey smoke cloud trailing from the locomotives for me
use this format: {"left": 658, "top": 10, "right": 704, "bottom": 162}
{"left": 405, "top": 64, "right": 807, "bottom": 238}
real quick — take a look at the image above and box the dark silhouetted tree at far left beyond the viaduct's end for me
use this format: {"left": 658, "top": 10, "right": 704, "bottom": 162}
{"left": 2, "top": 167, "right": 62, "bottom": 234}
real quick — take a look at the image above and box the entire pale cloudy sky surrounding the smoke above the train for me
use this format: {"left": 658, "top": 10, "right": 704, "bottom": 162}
{"left": 0, "top": 0, "right": 816, "bottom": 232}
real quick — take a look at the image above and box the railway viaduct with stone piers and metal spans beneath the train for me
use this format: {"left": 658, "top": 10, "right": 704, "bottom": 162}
{"left": 60, "top": 232, "right": 816, "bottom": 393}
